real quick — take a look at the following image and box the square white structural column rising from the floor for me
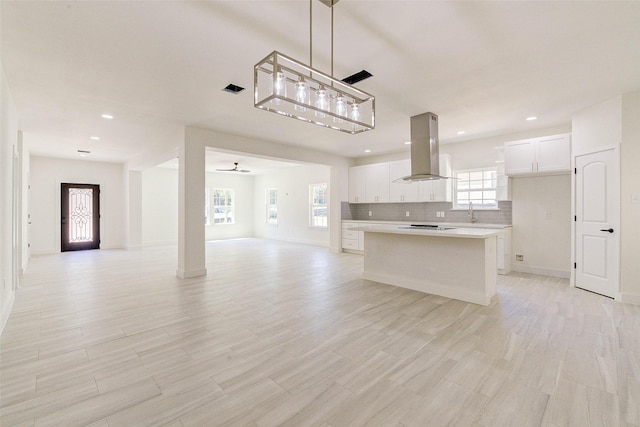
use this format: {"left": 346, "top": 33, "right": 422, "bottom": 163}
{"left": 176, "top": 136, "right": 207, "bottom": 279}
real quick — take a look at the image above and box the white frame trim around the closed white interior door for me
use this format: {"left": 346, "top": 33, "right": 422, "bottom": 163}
{"left": 569, "top": 144, "right": 622, "bottom": 301}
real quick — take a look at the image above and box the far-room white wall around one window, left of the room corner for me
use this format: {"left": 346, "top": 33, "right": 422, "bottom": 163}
{"left": 205, "top": 172, "right": 255, "bottom": 240}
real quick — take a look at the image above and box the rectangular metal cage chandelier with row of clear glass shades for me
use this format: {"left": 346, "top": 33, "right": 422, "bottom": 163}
{"left": 254, "top": 51, "right": 375, "bottom": 134}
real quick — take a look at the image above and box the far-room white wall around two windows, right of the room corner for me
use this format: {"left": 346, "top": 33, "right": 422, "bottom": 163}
{"left": 254, "top": 166, "right": 331, "bottom": 247}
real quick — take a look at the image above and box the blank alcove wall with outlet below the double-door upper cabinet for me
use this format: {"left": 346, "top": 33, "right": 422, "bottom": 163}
{"left": 511, "top": 174, "right": 571, "bottom": 277}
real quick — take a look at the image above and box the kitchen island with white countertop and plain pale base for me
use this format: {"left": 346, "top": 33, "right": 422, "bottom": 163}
{"left": 356, "top": 225, "right": 500, "bottom": 305}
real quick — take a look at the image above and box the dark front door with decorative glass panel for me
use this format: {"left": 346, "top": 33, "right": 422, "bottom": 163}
{"left": 60, "top": 184, "right": 100, "bottom": 252}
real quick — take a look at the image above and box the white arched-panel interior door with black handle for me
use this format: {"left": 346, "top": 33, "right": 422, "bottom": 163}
{"left": 575, "top": 148, "right": 620, "bottom": 298}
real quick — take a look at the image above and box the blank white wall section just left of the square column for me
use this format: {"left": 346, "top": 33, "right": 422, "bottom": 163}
{"left": 141, "top": 167, "right": 178, "bottom": 246}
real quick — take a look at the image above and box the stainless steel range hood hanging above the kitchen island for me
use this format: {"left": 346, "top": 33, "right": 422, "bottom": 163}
{"left": 393, "top": 113, "right": 448, "bottom": 182}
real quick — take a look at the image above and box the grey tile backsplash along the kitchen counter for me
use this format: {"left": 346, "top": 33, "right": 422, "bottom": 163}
{"left": 341, "top": 202, "right": 511, "bottom": 224}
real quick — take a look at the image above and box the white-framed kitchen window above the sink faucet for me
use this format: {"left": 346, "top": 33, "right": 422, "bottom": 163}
{"left": 453, "top": 167, "right": 498, "bottom": 210}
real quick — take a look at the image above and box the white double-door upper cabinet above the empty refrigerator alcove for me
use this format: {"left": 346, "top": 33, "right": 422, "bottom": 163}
{"left": 504, "top": 134, "right": 571, "bottom": 176}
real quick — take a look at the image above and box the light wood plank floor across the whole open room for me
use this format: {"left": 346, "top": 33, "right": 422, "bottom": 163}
{"left": 0, "top": 239, "right": 640, "bottom": 427}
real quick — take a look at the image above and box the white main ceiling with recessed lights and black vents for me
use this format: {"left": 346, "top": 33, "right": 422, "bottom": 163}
{"left": 0, "top": 0, "right": 640, "bottom": 171}
